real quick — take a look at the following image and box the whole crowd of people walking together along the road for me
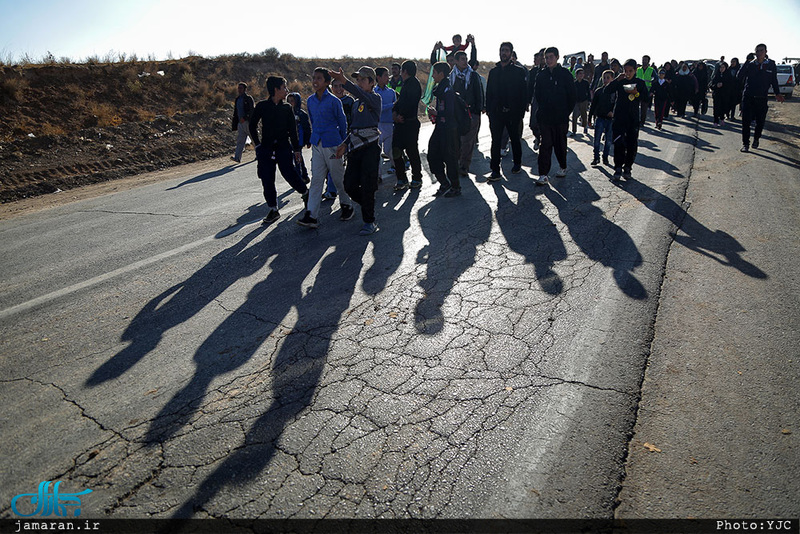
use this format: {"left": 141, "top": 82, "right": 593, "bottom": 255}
{"left": 233, "top": 40, "right": 783, "bottom": 235}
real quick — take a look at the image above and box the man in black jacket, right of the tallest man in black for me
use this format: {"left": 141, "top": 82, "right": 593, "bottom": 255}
{"left": 535, "top": 46, "right": 575, "bottom": 185}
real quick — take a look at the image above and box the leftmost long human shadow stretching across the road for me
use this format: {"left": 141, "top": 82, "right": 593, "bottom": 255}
{"left": 86, "top": 227, "right": 269, "bottom": 387}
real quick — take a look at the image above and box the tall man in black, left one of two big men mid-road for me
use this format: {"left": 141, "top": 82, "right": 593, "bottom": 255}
{"left": 486, "top": 42, "right": 528, "bottom": 182}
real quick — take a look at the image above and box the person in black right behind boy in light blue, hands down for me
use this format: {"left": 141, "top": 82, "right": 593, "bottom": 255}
{"left": 392, "top": 60, "right": 422, "bottom": 191}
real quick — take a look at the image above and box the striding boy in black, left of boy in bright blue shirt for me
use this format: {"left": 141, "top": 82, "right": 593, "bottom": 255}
{"left": 250, "top": 76, "right": 308, "bottom": 224}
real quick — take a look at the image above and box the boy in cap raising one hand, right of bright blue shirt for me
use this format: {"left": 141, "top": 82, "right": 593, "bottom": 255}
{"left": 331, "top": 66, "right": 382, "bottom": 235}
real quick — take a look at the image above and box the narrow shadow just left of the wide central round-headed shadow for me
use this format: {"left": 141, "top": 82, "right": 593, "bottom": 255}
{"left": 362, "top": 189, "right": 420, "bottom": 295}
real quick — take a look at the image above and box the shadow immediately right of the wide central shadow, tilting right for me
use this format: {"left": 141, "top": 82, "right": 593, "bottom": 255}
{"left": 492, "top": 179, "right": 567, "bottom": 295}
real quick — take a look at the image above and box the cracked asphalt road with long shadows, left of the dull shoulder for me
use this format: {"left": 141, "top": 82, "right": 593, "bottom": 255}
{"left": 0, "top": 101, "right": 796, "bottom": 518}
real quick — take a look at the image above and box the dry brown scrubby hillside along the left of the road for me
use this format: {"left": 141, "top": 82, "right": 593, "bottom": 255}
{"left": 0, "top": 49, "right": 472, "bottom": 203}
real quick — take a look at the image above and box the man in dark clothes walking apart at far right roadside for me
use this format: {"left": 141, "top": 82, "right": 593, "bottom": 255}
{"left": 738, "top": 44, "right": 783, "bottom": 152}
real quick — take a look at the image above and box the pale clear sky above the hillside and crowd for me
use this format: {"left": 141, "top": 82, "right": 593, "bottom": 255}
{"left": 0, "top": 0, "right": 800, "bottom": 64}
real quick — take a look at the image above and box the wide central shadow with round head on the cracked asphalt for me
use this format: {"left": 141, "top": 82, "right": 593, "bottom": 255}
{"left": 414, "top": 179, "right": 492, "bottom": 335}
